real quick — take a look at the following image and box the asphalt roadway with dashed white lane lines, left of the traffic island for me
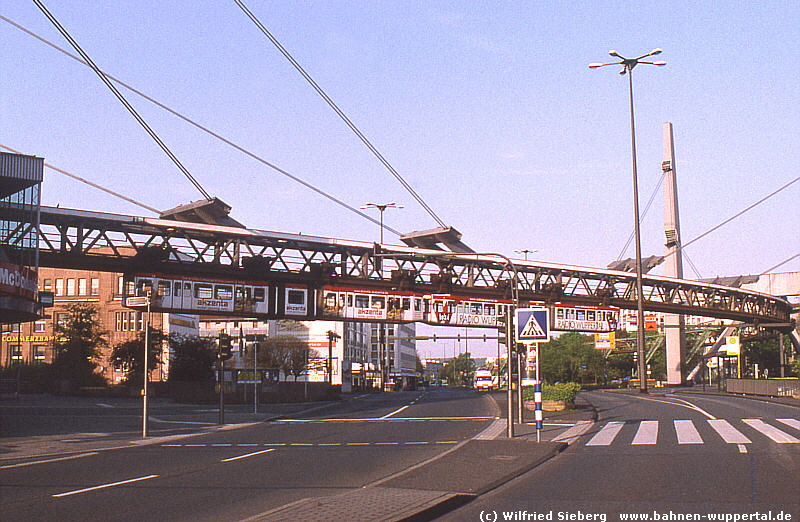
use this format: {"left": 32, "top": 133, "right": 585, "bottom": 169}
{"left": 0, "top": 389, "right": 498, "bottom": 521}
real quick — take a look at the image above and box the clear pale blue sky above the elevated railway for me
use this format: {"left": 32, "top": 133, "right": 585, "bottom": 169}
{"left": 0, "top": 0, "right": 800, "bottom": 358}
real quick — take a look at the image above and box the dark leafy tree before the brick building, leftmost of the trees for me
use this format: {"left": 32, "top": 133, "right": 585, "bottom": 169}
{"left": 53, "top": 303, "right": 107, "bottom": 390}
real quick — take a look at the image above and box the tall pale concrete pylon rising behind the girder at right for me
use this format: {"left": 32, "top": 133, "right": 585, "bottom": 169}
{"left": 661, "top": 122, "right": 686, "bottom": 386}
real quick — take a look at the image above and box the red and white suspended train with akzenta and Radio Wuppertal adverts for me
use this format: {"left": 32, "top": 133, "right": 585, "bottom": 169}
{"left": 123, "top": 273, "right": 619, "bottom": 332}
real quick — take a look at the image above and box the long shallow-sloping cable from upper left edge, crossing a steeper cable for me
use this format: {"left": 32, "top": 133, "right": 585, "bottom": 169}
{"left": 0, "top": 15, "right": 402, "bottom": 236}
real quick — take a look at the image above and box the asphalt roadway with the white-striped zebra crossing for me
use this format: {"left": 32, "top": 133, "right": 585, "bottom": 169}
{"left": 442, "top": 391, "right": 800, "bottom": 522}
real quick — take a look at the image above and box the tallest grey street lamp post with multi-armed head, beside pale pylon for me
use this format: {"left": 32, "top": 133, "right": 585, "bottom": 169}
{"left": 589, "top": 49, "right": 667, "bottom": 393}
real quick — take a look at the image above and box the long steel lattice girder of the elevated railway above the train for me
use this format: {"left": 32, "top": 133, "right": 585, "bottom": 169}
{"left": 7, "top": 207, "right": 792, "bottom": 329}
